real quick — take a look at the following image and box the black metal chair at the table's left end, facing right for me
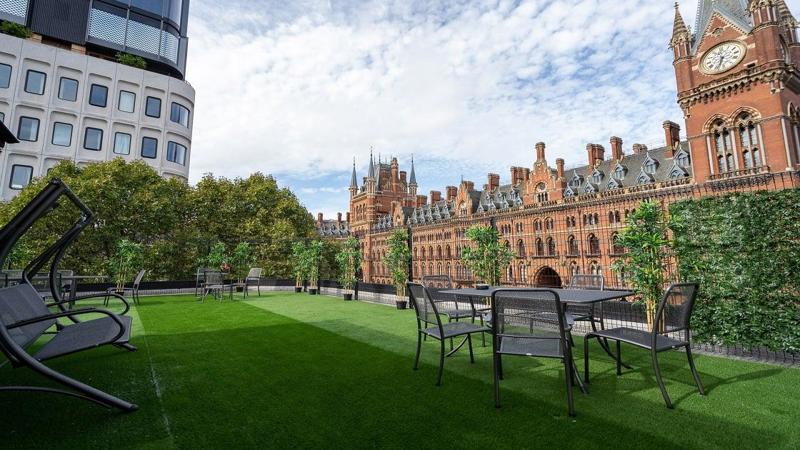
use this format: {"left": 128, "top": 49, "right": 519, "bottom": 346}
{"left": 406, "top": 283, "right": 486, "bottom": 386}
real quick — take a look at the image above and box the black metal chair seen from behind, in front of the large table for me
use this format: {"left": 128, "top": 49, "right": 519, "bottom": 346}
{"left": 492, "top": 289, "right": 577, "bottom": 416}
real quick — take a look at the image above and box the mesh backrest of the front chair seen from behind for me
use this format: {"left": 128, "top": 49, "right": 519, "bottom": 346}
{"left": 492, "top": 289, "right": 567, "bottom": 342}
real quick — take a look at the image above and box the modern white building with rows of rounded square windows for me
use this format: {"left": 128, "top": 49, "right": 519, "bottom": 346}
{"left": 0, "top": 0, "right": 195, "bottom": 201}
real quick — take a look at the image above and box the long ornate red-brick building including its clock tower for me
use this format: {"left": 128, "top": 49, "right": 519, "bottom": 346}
{"left": 319, "top": 0, "right": 800, "bottom": 286}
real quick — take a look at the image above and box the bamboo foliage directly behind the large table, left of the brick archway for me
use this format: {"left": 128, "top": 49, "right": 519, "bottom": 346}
{"left": 461, "top": 225, "right": 514, "bottom": 286}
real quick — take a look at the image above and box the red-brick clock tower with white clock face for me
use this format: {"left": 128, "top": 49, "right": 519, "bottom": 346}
{"left": 670, "top": 0, "right": 800, "bottom": 183}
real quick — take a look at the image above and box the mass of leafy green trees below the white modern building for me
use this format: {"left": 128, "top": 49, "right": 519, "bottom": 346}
{"left": 0, "top": 159, "right": 315, "bottom": 280}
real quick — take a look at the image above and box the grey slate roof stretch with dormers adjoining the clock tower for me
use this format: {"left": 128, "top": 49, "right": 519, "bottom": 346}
{"left": 564, "top": 142, "right": 692, "bottom": 197}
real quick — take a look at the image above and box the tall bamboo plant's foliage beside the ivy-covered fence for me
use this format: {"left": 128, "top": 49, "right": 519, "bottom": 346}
{"left": 614, "top": 201, "right": 670, "bottom": 316}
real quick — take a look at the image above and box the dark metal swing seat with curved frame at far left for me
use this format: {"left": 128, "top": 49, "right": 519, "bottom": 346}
{"left": 0, "top": 180, "right": 137, "bottom": 411}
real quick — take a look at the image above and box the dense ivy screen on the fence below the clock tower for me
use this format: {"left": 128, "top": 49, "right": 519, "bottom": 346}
{"left": 670, "top": 189, "right": 800, "bottom": 352}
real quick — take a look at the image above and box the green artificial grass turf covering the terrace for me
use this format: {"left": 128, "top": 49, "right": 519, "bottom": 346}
{"left": 0, "top": 293, "right": 800, "bottom": 448}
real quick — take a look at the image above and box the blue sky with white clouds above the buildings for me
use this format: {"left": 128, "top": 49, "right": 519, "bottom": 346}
{"left": 186, "top": 0, "right": 800, "bottom": 218}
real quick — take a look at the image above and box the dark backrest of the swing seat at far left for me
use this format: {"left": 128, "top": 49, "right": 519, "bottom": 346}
{"left": 0, "top": 283, "right": 56, "bottom": 348}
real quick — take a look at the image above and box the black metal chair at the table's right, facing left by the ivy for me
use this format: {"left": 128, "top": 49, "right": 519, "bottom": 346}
{"left": 583, "top": 283, "right": 705, "bottom": 408}
